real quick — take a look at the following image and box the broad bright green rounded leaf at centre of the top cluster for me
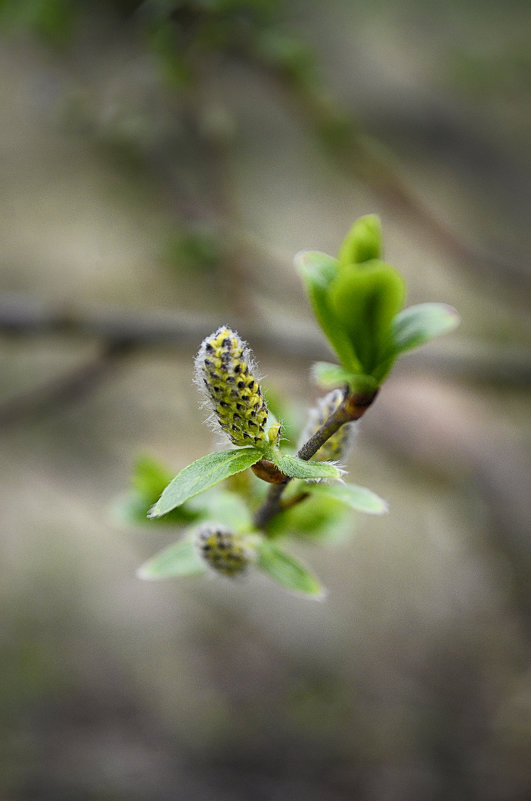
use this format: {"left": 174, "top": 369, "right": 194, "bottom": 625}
{"left": 329, "top": 260, "right": 405, "bottom": 375}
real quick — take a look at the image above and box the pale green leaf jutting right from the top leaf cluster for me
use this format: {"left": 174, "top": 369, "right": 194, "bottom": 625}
{"left": 392, "top": 303, "right": 460, "bottom": 353}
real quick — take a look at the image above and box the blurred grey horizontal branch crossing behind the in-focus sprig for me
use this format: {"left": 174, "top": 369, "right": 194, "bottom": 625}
{"left": 0, "top": 293, "right": 531, "bottom": 388}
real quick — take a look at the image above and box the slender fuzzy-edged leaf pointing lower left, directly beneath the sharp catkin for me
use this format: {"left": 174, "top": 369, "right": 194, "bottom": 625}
{"left": 149, "top": 448, "right": 263, "bottom": 517}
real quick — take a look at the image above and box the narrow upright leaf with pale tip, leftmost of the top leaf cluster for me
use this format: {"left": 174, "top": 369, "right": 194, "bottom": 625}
{"left": 295, "top": 251, "right": 361, "bottom": 372}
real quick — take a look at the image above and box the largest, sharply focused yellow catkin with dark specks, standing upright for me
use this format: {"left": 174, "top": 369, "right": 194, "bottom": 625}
{"left": 195, "top": 326, "right": 268, "bottom": 446}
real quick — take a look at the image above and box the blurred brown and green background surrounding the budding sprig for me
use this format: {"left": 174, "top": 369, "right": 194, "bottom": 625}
{"left": 0, "top": 0, "right": 531, "bottom": 801}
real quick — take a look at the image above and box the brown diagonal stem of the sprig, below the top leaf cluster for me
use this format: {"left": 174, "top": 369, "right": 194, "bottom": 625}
{"left": 254, "top": 390, "right": 378, "bottom": 528}
